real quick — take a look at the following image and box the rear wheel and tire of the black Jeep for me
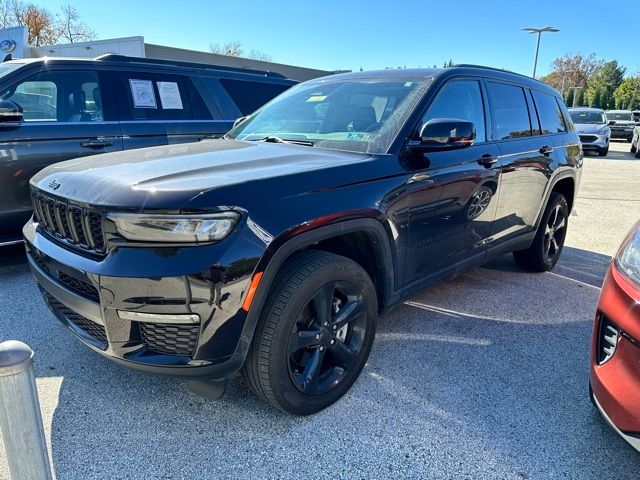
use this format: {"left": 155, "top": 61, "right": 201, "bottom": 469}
{"left": 513, "top": 192, "right": 569, "bottom": 272}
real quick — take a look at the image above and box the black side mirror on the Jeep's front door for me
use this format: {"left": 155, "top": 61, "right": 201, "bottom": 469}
{"left": 410, "top": 118, "right": 476, "bottom": 151}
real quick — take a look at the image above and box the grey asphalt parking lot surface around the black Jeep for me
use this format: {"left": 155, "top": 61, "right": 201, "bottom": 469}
{"left": 0, "top": 143, "right": 640, "bottom": 480}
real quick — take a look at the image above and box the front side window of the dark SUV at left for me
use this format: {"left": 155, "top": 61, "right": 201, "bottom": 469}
{"left": 0, "top": 70, "right": 104, "bottom": 122}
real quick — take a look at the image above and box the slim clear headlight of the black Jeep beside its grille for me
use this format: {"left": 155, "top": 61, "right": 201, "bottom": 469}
{"left": 107, "top": 212, "right": 240, "bottom": 243}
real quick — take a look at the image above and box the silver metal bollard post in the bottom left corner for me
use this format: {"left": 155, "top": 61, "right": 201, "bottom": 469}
{"left": 0, "top": 340, "right": 53, "bottom": 480}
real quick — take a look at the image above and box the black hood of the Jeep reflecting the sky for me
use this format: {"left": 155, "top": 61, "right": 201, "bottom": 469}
{"left": 31, "top": 140, "right": 370, "bottom": 209}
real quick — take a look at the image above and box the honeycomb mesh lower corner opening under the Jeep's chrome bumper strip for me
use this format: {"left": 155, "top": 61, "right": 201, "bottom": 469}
{"left": 139, "top": 322, "right": 200, "bottom": 356}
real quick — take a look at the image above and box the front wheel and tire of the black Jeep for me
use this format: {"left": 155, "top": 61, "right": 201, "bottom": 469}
{"left": 242, "top": 250, "right": 378, "bottom": 415}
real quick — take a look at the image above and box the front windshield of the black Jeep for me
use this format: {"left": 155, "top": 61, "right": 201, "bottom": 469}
{"left": 227, "top": 78, "right": 430, "bottom": 153}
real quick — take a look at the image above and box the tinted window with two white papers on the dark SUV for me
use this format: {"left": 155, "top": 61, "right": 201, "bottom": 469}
{"left": 117, "top": 72, "right": 218, "bottom": 120}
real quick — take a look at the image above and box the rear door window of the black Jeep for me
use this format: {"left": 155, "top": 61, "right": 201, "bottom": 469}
{"left": 487, "top": 82, "right": 531, "bottom": 140}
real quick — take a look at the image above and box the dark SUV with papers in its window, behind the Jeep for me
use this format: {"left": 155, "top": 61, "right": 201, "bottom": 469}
{"left": 0, "top": 55, "right": 296, "bottom": 246}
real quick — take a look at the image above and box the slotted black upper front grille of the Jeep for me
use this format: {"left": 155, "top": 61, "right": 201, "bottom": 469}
{"left": 31, "top": 191, "right": 105, "bottom": 254}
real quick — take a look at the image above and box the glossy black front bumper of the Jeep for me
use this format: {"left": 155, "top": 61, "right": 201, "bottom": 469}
{"left": 23, "top": 221, "right": 261, "bottom": 379}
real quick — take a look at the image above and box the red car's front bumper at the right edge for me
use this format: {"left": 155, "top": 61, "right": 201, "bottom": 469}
{"left": 590, "top": 266, "right": 640, "bottom": 450}
